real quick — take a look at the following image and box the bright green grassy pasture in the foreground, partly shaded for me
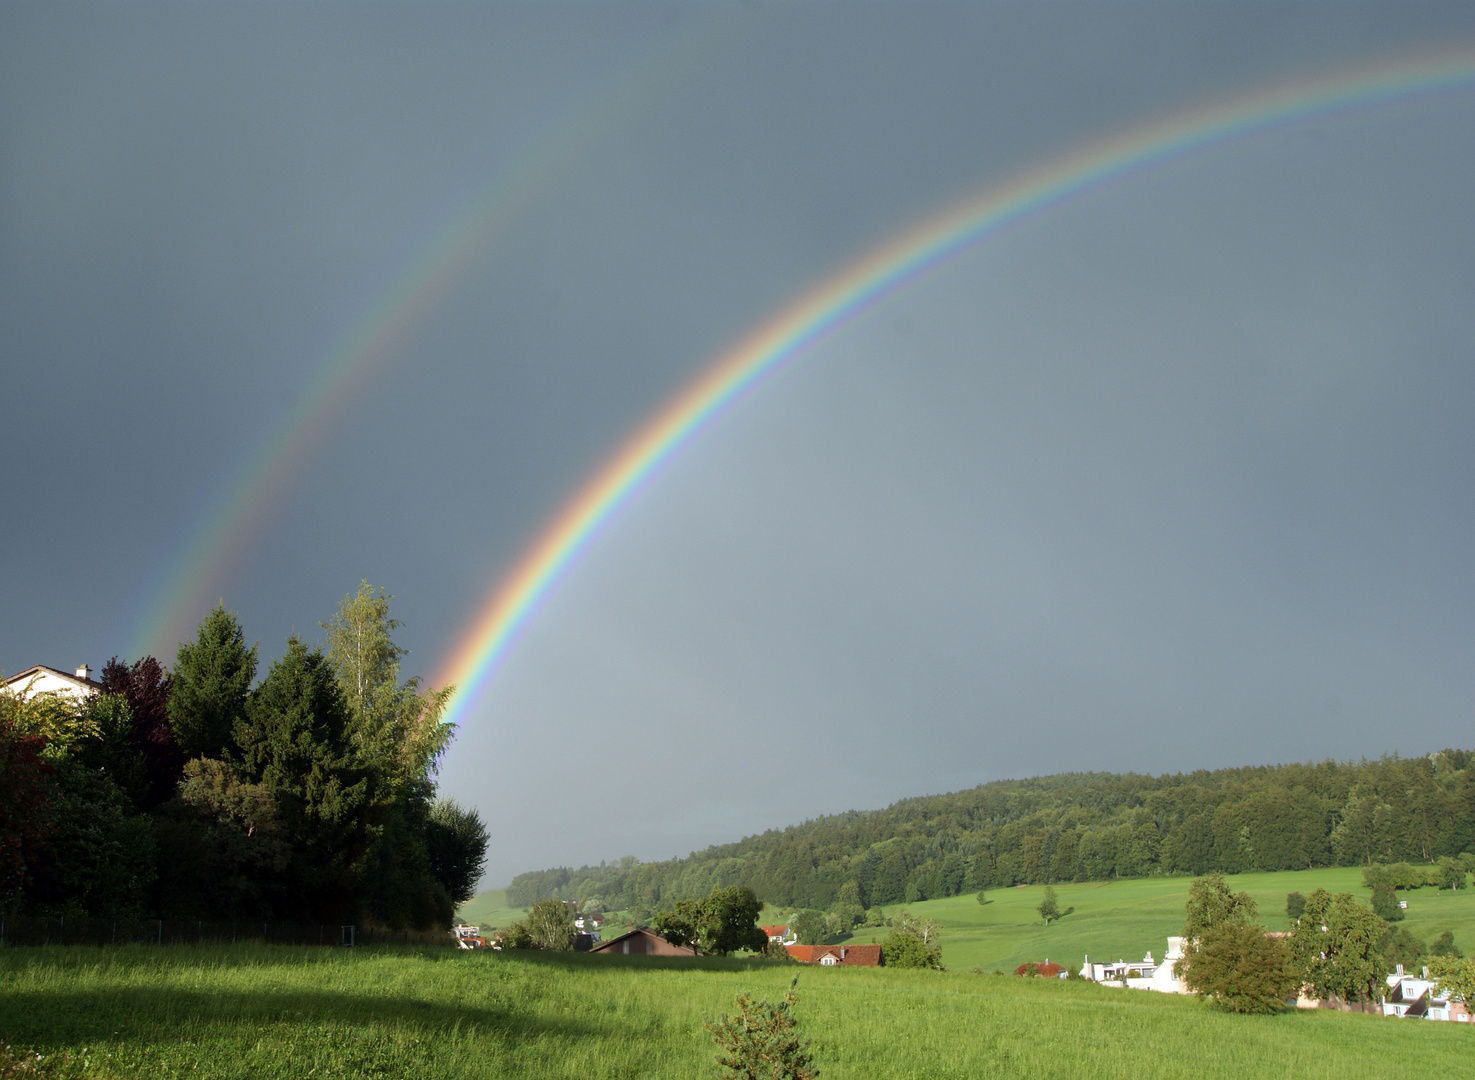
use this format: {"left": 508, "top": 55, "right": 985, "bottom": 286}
{"left": 0, "top": 938, "right": 1475, "bottom": 1080}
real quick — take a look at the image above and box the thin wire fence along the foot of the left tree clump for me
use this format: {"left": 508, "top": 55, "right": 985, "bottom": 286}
{"left": 0, "top": 916, "right": 457, "bottom": 949}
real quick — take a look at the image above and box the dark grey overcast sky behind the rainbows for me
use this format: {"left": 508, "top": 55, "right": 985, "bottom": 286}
{"left": 0, "top": 0, "right": 1475, "bottom": 885}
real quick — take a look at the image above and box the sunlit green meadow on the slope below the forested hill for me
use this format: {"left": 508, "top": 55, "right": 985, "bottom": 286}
{"left": 826, "top": 868, "right": 1475, "bottom": 971}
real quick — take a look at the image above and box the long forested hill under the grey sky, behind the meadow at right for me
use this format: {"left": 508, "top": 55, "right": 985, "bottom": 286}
{"left": 507, "top": 750, "right": 1475, "bottom": 910}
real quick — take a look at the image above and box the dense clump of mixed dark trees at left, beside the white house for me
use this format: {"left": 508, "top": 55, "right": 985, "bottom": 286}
{"left": 0, "top": 583, "right": 487, "bottom": 930}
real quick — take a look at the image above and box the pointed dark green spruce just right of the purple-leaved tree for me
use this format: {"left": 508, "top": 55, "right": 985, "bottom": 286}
{"left": 167, "top": 603, "right": 257, "bottom": 758}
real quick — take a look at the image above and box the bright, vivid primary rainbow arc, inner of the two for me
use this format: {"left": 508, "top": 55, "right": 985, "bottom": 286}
{"left": 437, "top": 50, "right": 1475, "bottom": 720}
